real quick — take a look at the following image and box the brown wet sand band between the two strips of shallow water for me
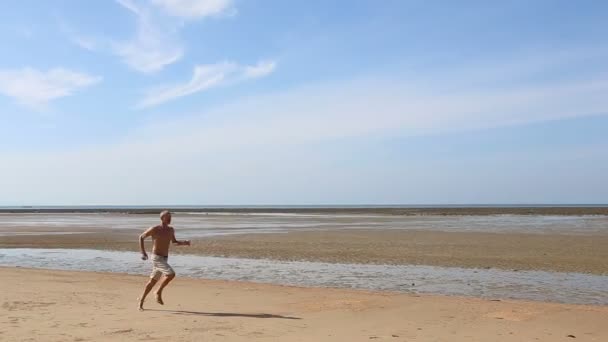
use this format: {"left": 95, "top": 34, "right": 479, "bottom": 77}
{"left": 0, "top": 228, "right": 608, "bottom": 275}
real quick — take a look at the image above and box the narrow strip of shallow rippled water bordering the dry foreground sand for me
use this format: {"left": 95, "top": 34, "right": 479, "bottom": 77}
{"left": 0, "top": 248, "right": 608, "bottom": 305}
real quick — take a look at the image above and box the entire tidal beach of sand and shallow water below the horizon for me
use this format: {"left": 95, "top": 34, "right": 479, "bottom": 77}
{"left": 0, "top": 209, "right": 608, "bottom": 342}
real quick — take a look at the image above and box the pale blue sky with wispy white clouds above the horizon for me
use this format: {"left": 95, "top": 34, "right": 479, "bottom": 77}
{"left": 0, "top": 0, "right": 608, "bottom": 206}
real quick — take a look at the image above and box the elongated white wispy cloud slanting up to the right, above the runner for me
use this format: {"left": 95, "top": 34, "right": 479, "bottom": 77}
{"left": 137, "top": 61, "right": 276, "bottom": 108}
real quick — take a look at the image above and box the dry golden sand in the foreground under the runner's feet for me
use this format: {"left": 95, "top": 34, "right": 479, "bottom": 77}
{"left": 0, "top": 268, "right": 608, "bottom": 342}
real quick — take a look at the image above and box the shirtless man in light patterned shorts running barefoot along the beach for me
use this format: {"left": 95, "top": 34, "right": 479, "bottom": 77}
{"left": 139, "top": 210, "right": 190, "bottom": 311}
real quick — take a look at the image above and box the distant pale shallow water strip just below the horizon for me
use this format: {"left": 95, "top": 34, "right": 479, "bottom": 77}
{"left": 0, "top": 213, "right": 608, "bottom": 238}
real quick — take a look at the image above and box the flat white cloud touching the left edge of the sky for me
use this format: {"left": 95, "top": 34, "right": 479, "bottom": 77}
{"left": 0, "top": 68, "right": 102, "bottom": 108}
